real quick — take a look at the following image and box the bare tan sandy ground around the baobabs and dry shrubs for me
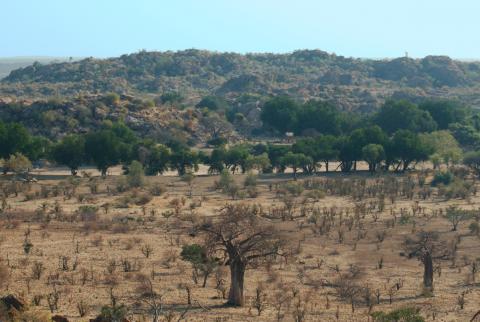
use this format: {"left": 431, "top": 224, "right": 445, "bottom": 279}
{"left": 0, "top": 167, "right": 480, "bottom": 321}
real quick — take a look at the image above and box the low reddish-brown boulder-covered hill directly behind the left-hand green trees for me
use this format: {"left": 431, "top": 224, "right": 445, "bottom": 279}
{"left": 0, "top": 94, "right": 246, "bottom": 145}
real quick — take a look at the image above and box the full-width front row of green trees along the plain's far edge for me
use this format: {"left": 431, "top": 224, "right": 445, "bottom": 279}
{"left": 2, "top": 123, "right": 462, "bottom": 176}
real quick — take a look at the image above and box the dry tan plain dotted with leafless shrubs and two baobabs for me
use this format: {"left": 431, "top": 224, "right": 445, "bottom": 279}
{"left": 0, "top": 168, "right": 480, "bottom": 321}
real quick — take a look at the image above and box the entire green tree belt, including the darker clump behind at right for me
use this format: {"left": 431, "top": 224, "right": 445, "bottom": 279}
{"left": 0, "top": 97, "right": 477, "bottom": 179}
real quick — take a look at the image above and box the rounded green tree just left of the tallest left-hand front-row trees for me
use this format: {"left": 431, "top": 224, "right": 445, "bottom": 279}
{"left": 51, "top": 135, "right": 85, "bottom": 175}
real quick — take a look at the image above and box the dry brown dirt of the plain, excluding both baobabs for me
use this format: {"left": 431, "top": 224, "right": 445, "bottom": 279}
{"left": 0, "top": 167, "right": 480, "bottom": 321}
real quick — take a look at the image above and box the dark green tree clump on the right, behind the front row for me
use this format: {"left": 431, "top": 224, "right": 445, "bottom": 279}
{"left": 261, "top": 97, "right": 470, "bottom": 135}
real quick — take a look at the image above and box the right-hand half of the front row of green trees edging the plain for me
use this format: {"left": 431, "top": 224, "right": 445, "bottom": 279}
{"left": 206, "top": 125, "right": 462, "bottom": 175}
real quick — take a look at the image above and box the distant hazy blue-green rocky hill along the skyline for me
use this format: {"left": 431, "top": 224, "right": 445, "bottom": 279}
{"left": 0, "top": 50, "right": 480, "bottom": 111}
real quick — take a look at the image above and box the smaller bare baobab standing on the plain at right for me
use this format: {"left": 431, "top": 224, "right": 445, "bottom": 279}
{"left": 404, "top": 231, "right": 450, "bottom": 292}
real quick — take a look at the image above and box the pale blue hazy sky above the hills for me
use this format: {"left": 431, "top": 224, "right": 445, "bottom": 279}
{"left": 0, "top": 0, "right": 480, "bottom": 58}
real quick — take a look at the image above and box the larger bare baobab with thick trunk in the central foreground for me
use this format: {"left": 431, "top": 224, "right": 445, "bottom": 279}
{"left": 200, "top": 204, "right": 286, "bottom": 306}
